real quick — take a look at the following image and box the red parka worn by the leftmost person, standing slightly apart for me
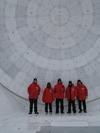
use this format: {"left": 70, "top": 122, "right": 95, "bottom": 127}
{"left": 27, "top": 82, "right": 41, "bottom": 99}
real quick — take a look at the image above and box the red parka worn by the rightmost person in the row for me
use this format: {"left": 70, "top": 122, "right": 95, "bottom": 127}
{"left": 77, "top": 84, "right": 88, "bottom": 100}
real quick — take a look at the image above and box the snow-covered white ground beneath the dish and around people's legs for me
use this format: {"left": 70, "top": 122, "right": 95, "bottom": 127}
{"left": 0, "top": 86, "right": 100, "bottom": 133}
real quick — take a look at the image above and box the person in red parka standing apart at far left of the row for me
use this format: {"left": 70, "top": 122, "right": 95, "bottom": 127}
{"left": 27, "top": 78, "right": 41, "bottom": 114}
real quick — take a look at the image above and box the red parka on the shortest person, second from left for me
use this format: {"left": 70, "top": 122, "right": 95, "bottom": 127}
{"left": 42, "top": 88, "right": 54, "bottom": 103}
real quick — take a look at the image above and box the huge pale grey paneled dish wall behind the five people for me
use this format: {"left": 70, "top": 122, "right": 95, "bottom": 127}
{"left": 0, "top": 0, "right": 100, "bottom": 101}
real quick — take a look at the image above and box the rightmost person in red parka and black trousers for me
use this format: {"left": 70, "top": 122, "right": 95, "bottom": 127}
{"left": 77, "top": 80, "right": 88, "bottom": 113}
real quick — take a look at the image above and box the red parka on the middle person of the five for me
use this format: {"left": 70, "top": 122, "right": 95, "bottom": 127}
{"left": 54, "top": 83, "right": 65, "bottom": 99}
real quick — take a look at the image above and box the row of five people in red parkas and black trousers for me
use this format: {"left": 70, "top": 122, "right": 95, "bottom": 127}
{"left": 27, "top": 78, "right": 88, "bottom": 114}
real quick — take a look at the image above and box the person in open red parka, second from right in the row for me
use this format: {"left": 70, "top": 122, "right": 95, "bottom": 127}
{"left": 66, "top": 81, "right": 77, "bottom": 113}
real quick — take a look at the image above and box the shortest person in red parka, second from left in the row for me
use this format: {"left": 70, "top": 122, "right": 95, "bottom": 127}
{"left": 42, "top": 82, "right": 54, "bottom": 114}
